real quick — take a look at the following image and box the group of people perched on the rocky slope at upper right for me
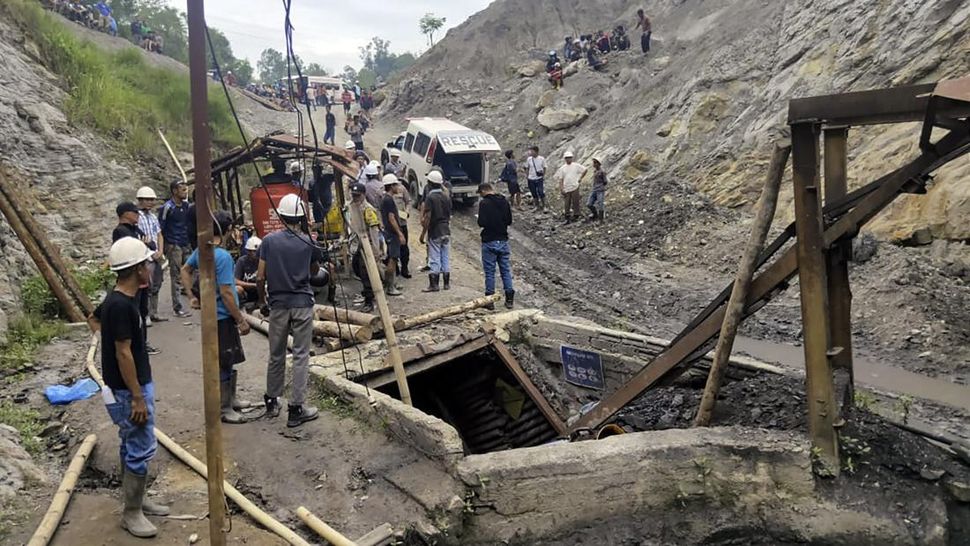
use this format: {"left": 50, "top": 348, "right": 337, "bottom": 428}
{"left": 546, "top": 9, "right": 653, "bottom": 89}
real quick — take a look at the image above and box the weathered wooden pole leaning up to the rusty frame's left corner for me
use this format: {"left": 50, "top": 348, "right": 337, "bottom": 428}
{"left": 694, "top": 142, "right": 791, "bottom": 427}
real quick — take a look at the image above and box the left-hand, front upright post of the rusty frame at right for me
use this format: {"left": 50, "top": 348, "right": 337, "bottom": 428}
{"left": 791, "top": 123, "right": 840, "bottom": 475}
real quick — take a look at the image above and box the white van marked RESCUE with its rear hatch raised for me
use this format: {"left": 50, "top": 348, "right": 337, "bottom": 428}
{"left": 381, "top": 118, "right": 502, "bottom": 207}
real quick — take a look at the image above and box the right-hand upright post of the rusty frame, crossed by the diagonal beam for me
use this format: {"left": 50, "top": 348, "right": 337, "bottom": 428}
{"left": 823, "top": 127, "right": 855, "bottom": 415}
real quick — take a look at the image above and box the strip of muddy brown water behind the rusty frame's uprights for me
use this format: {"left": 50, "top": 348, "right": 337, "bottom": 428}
{"left": 734, "top": 336, "right": 970, "bottom": 411}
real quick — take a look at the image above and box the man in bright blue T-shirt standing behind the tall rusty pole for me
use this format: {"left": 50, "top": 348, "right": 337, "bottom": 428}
{"left": 180, "top": 210, "right": 249, "bottom": 424}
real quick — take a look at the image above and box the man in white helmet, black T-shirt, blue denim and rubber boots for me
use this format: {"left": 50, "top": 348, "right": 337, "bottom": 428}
{"left": 89, "top": 237, "right": 169, "bottom": 538}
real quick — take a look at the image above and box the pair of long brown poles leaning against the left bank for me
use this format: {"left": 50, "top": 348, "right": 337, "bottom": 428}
{"left": 0, "top": 169, "right": 94, "bottom": 322}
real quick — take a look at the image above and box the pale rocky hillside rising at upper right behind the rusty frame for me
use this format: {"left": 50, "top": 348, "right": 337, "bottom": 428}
{"left": 384, "top": 0, "right": 970, "bottom": 240}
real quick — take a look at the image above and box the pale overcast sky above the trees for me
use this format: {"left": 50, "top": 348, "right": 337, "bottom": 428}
{"left": 181, "top": 0, "right": 491, "bottom": 72}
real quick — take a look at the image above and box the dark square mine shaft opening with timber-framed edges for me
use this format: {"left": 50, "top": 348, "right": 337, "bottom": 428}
{"left": 362, "top": 336, "right": 565, "bottom": 454}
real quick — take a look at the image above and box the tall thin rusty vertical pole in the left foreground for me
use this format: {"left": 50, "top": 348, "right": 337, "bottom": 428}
{"left": 180, "top": 0, "right": 227, "bottom": 536}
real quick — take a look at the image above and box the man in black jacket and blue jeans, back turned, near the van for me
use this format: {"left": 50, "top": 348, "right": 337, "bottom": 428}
{"left": 478, "top": 182, "right": 515, "bottom": 309}
